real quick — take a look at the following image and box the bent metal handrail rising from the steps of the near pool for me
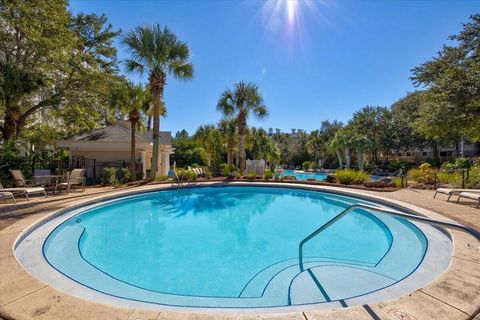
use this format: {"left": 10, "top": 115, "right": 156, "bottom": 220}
{"left": 298, "top": 203, "right": 480, "bottom": 271}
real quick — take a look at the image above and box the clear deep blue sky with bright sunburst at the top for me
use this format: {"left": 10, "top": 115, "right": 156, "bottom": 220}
{"left": 70, "top": 0, "right": 480, "bottom": 133}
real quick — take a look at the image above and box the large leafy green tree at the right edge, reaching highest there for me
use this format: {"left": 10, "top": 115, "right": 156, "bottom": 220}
{"left": 411, "top": 14, "right": 480, "bottom": 142}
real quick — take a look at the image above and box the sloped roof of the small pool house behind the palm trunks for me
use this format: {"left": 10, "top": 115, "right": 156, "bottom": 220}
{"left": 63, "top": 120, "right": 172, "bottom": 144}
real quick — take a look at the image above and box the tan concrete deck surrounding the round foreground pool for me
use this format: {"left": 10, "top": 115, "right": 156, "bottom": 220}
{"left": 0, "top": 184, "right": 480, "bottom": 320}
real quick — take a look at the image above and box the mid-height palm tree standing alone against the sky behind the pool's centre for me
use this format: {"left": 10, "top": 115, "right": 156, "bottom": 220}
{"left": 217, "top": 81, "right": 268, "bottom": 176}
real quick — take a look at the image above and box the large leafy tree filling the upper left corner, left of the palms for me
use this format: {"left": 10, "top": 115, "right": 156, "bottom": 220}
{"left": 0, "top": 0, "right": 118, "bottom": 140}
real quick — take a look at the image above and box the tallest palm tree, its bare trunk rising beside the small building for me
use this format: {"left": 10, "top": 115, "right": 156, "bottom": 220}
{"left": 122, "top": 24, "right": 193, "bottom": 179}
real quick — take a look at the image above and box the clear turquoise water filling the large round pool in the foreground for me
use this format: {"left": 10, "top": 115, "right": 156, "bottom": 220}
{"left": 44, "top": 186, "right": 427, "bottom": 307}
